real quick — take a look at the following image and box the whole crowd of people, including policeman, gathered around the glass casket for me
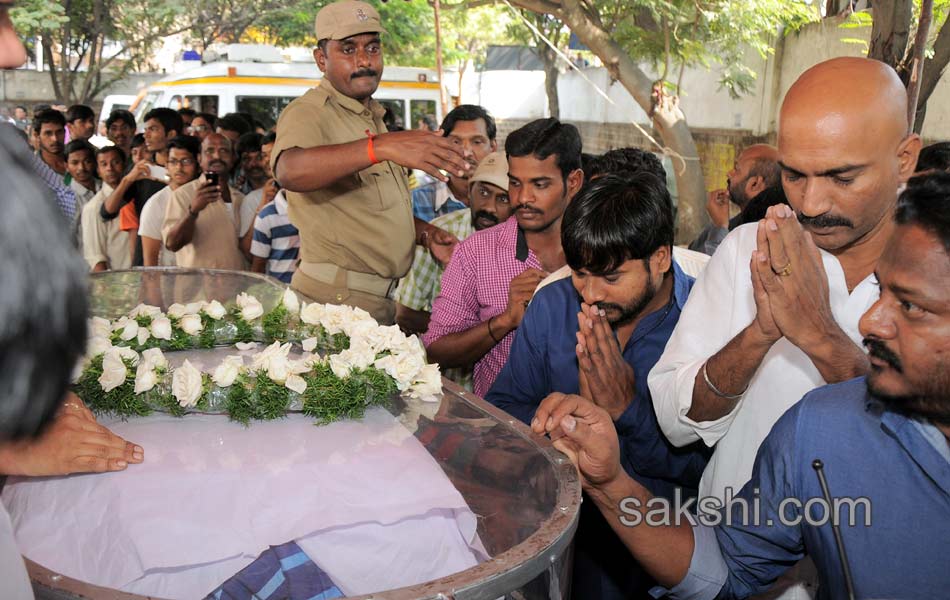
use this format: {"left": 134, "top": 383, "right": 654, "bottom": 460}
{"left": 0, "top": 0, "right": 950, "bottom": 600}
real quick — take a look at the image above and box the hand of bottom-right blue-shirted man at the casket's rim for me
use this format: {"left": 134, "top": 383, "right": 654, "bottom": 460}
{"left": 531, "top": 392, "right": 623, "bottom": 488}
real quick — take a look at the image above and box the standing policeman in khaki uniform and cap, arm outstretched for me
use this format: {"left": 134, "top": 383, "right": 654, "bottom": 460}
{"left": 271, "top": 0, "right": 471, "bottom": 324}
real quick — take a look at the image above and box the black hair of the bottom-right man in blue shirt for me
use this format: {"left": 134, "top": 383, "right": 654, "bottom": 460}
{"left": 894, "top": 171, "right": 950, "bottom": 254}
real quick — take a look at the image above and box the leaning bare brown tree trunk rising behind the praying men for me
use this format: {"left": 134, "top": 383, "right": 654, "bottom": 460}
{"left": 528, "top": 0, "right": 709, "bottom": 244}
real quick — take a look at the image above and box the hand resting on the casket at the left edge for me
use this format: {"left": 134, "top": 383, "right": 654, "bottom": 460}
{"left": 0, "top": 392, "right": 145, "bottom": 477}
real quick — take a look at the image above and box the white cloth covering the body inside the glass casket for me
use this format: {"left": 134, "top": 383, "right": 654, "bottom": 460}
{"left": 3, "top": 408, "right": 481, "bottom": 598}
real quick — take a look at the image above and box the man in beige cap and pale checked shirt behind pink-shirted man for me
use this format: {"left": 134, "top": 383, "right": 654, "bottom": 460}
{"left": 393, "top": 152, "right": 511, "bottom": 389}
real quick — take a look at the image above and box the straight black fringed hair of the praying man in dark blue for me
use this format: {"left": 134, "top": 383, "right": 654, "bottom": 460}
{"left": 561, "top": 171, "right": 673, "bottom": 275}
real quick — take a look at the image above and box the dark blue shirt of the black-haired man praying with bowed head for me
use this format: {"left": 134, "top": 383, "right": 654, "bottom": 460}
{"left": 485, "top": 261, "right": 708, "bottom": 600}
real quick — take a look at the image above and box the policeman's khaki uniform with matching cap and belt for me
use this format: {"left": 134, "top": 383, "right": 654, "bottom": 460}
{"left": 271, "top": 0, "right": 415, "bottom": 325}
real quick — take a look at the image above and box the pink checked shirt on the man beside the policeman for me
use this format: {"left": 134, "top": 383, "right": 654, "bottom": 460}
{"left": 422, "top": 218, "right": 543, "bottom": 397}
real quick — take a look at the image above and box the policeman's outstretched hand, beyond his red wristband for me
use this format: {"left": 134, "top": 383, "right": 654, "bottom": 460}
{"left": 373, "top": 130, "right": 475, "bottom": 181}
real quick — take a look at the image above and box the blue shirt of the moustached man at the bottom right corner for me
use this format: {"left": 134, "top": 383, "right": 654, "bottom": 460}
{"left": 671, "top": 377, "right": 950, "bottom": 599}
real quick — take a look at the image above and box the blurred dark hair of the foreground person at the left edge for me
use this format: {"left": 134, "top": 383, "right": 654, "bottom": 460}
{"left": 0, "top": 128, "right": 88, "bottom": 441}
